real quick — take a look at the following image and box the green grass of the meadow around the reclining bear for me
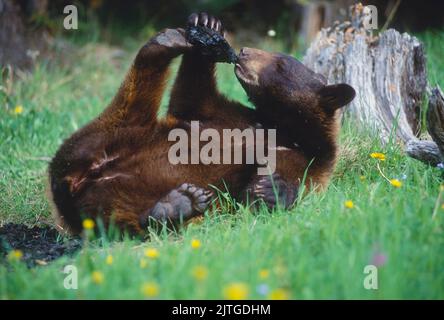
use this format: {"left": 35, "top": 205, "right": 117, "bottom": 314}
{"left": 0, "top": 32, "right": 444, "bottom": 299}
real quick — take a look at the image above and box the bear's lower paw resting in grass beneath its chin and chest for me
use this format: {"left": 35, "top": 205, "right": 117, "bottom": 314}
{"left": 252, "top": 173, "right": 298, "bottom": 209}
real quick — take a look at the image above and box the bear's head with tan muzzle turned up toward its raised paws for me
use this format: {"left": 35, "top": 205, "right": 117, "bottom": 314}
{"left": 235, "top": 48, "right": 355, "bottom": 131}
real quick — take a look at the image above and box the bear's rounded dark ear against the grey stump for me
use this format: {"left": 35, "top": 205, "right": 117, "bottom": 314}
{"left": 319, "top": 83, "right": 356, "bottom": 110}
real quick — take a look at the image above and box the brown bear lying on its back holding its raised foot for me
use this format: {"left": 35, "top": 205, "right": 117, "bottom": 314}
{"left": 49, "top": 13, "right": 355, "bottom": 234}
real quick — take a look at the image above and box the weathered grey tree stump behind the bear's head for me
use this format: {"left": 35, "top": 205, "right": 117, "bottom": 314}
{"left": 303, "top": 4, "right": 444, "bottom": 165}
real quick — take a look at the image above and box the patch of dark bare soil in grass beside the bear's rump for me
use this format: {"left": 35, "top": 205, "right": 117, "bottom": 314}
{"left": 0, "top": 223, "right": 82, "bottom": 267}
